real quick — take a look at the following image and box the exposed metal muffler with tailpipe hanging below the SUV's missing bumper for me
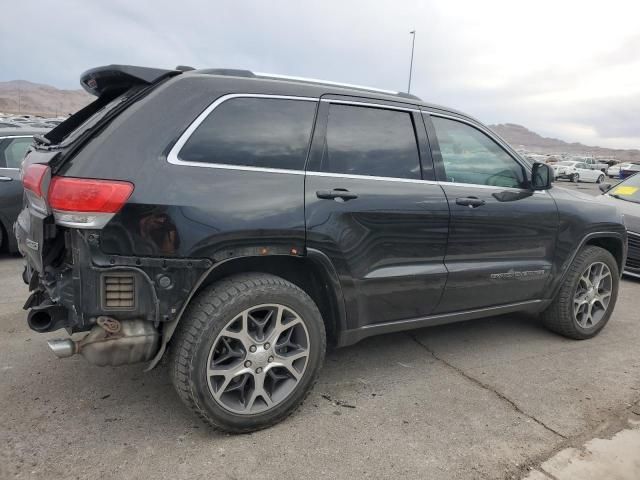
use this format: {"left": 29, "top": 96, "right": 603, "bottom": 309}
{"left": 47, "top": 317, "right": 160, "bottom": 367}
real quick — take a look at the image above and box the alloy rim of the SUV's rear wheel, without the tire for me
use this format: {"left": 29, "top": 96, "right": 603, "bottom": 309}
{"left": 206, "top": 304, "right": 309, "bottom": 415}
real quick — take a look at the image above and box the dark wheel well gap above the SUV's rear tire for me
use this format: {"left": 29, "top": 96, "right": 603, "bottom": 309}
{"left": 196, "top": 256, "right": 342, "bottom": 344}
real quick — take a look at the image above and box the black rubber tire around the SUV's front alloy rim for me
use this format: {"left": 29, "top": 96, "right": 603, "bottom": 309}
{"left": 542, "top": 246, "right": 620, "bottom": 340}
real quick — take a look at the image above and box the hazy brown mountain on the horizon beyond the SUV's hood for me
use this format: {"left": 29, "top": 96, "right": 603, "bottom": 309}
{"left": 489, "top": 123, "right": 640, "bottom": 161}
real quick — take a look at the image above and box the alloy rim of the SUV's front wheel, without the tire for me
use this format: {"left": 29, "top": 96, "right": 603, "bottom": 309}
{"left": 573, "top": 262, "right": 613, "bottom": 328}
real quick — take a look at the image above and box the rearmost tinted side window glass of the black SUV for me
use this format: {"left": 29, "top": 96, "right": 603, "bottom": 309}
{"left": 179, "top": 98, "right": 316, "bottom": 170}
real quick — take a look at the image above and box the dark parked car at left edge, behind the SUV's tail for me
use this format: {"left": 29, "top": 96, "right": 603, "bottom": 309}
{"left": 0, "top": 128, "right": 48, "bottom": 252}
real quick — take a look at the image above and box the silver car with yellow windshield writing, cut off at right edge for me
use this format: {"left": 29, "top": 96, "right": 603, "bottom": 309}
{"left": 598, "top": 175, "right": 640, "bottom": 278}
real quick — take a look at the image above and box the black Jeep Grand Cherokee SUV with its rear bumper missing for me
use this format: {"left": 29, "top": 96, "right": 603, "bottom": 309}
{"left": 15, "top": 65, "right": 626, "bottom": 432}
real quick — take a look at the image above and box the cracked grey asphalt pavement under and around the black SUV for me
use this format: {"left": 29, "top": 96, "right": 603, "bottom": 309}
{"left": 0, "top": 178, "right": 640, "bottom": 479}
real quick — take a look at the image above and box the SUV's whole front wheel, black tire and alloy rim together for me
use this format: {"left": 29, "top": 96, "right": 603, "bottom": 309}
{"left": 542, "top": 246, "right": 620, "bottom": 340}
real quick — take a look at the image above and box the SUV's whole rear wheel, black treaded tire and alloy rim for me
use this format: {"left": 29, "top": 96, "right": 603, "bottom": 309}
{"left": 172, "top": 273, "right": 326, "bottom": 433}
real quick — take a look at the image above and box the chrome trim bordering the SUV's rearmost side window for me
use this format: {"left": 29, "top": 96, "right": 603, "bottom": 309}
{"left": 167, "top": 93, "right": 319, "bottom": 175}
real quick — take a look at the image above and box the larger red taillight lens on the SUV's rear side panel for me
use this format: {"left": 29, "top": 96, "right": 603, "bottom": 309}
{"left": 49, "top": 177, "right": 133, "bottom": 213}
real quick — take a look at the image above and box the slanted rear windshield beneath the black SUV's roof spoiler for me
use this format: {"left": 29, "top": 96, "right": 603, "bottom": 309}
{"left": 44, "top": 86, "right": 144, "bottom": 145}
